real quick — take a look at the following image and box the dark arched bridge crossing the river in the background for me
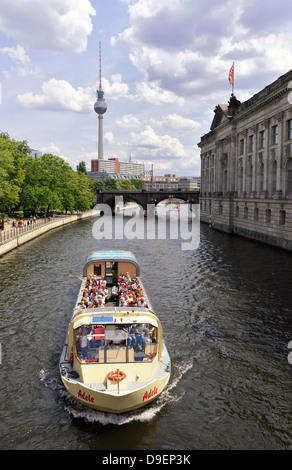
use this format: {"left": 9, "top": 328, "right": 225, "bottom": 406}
{"left": 97, "top": 189, "right": 200, "bottom": 211}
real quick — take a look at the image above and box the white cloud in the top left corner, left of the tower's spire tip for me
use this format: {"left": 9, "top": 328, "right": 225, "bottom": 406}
{"left": 0, "top": 0, "right": 96, "bottom": 52}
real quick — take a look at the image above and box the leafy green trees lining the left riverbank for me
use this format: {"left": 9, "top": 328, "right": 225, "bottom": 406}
{"left": 0, "top": 133, "right": 94, "bottom": 219}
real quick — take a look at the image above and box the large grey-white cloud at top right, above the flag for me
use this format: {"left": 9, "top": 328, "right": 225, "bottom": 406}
{"left": 111, "top": 0, "right": 292, "bottom": 97}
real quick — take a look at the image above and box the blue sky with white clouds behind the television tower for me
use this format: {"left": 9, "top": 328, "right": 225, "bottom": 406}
{"left": 0, "top": 0, "right": 292, "bottom": 176}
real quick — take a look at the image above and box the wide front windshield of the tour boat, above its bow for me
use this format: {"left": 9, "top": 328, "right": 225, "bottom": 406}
{"left": 74, "top": 323, "right": 157, "bottom": 364}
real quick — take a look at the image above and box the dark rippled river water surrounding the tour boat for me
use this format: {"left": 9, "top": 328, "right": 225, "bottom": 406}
{"left": 0, "top": 213, "right": 292, "bottom": 451}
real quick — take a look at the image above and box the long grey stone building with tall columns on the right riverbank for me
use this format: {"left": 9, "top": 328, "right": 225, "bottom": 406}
{"left": 198, "top": 70, "right": 292, "bottom": 250}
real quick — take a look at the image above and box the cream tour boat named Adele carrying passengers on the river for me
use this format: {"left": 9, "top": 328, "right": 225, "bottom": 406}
{"left": 59, "top": 250, "right": 171, "bottom": 413}
